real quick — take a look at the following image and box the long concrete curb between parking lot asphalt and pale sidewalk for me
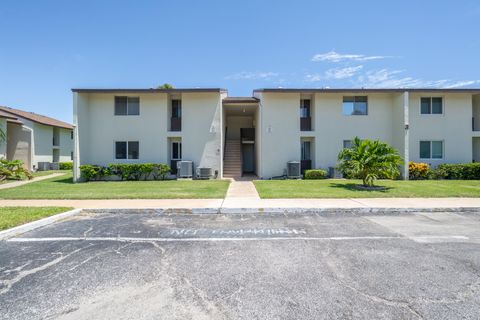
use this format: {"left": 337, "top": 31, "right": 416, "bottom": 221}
{"left": 82, "top": 207, "right": 480, "bottom": 216}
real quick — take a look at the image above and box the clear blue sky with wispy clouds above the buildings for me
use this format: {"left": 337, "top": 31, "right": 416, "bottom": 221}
{"left": 0, "top": 0, "right": 480, "bottom": 121}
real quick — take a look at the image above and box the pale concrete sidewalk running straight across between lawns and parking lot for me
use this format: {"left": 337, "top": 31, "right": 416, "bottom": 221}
{"left": 0, "top": 197, "right": 480, "bottom": 212}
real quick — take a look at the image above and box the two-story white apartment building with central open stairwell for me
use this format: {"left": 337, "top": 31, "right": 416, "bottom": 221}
{"left": 72, "top": 89, "right": 480, "bottom": 179}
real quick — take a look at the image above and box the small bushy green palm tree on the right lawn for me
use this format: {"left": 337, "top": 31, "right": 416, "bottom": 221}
{"left": 338, "top": 137, "right": 403, "bottom": 187}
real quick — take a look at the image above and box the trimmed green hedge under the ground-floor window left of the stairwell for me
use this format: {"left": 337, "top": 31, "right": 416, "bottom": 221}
{"left": 80, "top": 163, "right": 170, "bottom": 181}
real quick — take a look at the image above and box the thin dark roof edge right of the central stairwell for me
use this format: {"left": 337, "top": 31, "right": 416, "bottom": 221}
{"left": 253, "top": 88, "right": 480, "bottom": 93}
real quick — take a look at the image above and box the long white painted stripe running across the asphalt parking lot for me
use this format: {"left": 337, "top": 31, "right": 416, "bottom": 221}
{"left": 7, "top": 235, "right": 469, "bottom": 242}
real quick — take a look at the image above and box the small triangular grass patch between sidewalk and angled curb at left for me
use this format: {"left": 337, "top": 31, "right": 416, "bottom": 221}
{"left": 0, "top": 207, "right": 72, "bottom": 230}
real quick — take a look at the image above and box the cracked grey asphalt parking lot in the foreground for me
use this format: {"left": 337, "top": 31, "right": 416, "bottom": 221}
{"left": 0, "top": 212, "right": 480, "bottom": 319}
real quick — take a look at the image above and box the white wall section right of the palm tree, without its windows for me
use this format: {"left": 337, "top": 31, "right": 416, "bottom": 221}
{"left": 409, "top": 92, "right": 472, "bottom": 167}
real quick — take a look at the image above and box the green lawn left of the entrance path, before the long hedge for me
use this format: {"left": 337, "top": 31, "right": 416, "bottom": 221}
{"left": 0, "top": 174, "right": 229, "bottom": 199}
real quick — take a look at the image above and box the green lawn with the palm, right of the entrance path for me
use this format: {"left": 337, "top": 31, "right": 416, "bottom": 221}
{"left": 254, "top": 179, "right": 480, "bottom": 199}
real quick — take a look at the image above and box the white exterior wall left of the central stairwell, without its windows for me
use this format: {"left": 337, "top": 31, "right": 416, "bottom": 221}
{"left": 74, "top": 93, "right": 222, "bottom": 180}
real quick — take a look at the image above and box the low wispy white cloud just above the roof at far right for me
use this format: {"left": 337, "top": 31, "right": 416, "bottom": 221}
{"left": 356, "top": 69, "right": 480, "bottom": 88}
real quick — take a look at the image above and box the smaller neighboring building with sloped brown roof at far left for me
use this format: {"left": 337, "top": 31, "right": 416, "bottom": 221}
{"left": 0, "top": 106, "right": 73, "bottom": 170}
